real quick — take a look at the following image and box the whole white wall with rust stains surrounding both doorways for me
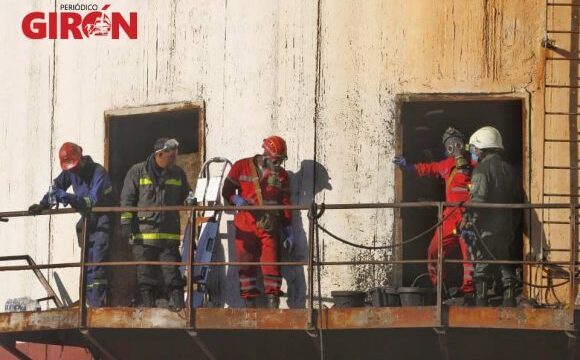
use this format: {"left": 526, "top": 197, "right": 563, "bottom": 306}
{"left": 0, "top": 0, "right": 544, "bottom": 306}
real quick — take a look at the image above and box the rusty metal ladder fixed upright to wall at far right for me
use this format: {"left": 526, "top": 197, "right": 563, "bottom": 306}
{"left": 540, "top": 0, "right": 580, "bottom": 359}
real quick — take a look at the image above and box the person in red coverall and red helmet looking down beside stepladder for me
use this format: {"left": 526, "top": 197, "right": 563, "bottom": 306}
{"left": 222, "top": 136, "right": 294, "bottom": 309}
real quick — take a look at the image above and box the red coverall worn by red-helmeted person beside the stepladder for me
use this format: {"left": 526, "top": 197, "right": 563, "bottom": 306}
{"left": 227, "top": 157, "right": 292, "bottom": 298}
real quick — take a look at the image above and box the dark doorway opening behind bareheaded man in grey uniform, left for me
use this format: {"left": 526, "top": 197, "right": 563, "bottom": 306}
{"left": 105, "top": 102, "right": 205, "bottom": 306}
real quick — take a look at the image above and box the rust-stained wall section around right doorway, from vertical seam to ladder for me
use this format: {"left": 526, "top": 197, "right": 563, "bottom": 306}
{"left": 317, "top": 0, "right": 544, "bottom": 296}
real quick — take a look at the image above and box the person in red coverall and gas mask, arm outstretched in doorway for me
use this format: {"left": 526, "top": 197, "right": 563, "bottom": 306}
{"left": 393, "top": 127, "right": 475, "bottom": 301}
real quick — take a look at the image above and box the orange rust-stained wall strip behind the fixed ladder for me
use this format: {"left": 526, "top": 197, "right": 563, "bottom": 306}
{"left": 530, "top": 1, "right": 580, "bottom": 305}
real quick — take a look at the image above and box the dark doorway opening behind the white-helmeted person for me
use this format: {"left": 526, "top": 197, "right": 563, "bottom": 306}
{"left": 396, "top": 95, "right": 525, "bottom": 288}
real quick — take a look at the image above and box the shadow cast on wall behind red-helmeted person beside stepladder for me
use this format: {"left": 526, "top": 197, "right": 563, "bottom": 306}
{"left": 221, "top": 160, "right": 332, "bottom": 308}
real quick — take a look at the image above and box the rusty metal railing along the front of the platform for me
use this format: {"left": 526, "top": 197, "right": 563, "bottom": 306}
{"left": 0, "top": 202, "right": 578, "bottom": 329}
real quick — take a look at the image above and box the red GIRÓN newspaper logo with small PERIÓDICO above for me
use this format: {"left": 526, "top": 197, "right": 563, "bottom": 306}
{"left": 22, "top": 4, "right": 137, "bottom": 40}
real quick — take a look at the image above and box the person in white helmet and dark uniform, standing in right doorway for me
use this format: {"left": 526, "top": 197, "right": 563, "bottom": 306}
{"left": 462, "top": 126, "right": 517, "bottom": 307}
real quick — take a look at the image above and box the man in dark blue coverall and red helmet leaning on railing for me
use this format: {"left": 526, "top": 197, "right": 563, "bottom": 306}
{"left": 28, "top": 142, "right": 116, "bottom": 307}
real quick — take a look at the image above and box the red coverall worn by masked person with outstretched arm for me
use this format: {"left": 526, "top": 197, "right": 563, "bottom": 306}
{"left": 415, "top": 156, "right": 474, "bottom": 293}
